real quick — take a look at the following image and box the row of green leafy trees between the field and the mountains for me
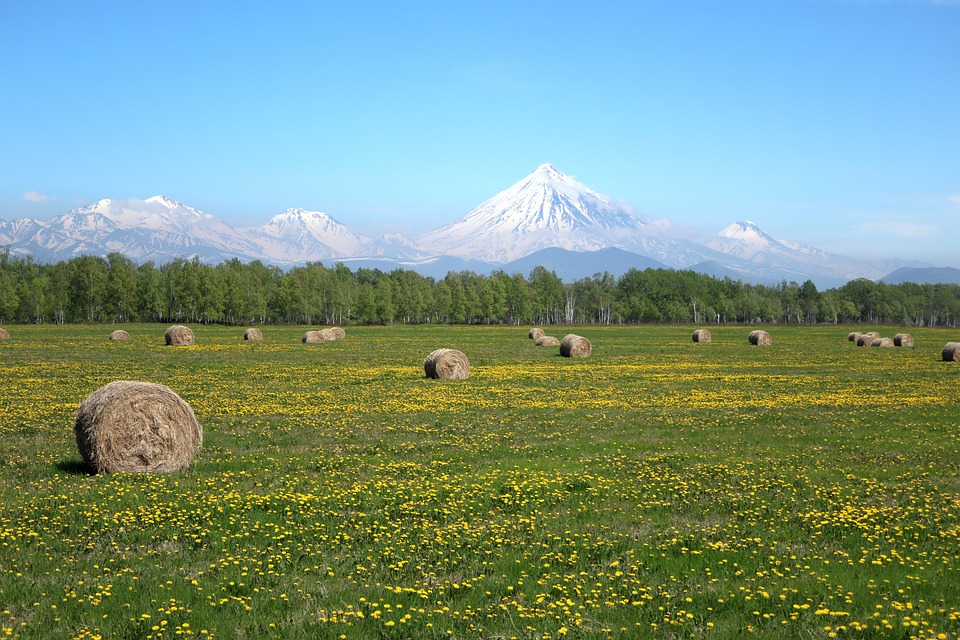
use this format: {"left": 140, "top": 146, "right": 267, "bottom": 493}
{"left": 0, "top": 250, "right": 960, "bottom": 327}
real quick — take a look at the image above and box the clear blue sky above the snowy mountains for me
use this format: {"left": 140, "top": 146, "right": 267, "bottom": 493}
{"left": 0, "top": 0, "right": 960, "bottom": 268}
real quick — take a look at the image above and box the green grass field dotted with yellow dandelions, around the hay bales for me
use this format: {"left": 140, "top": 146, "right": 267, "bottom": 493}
{"left": 0, "top": 325, "right": 960, "bottom": 639}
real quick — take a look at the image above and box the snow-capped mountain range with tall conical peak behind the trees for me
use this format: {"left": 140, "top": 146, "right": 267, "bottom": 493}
{"left": 0, "top": 164, "right": 923, "bottom": 288}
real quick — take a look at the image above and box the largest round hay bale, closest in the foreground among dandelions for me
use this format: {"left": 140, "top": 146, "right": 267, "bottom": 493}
{"left": 74, "top": 380, "right": 203, "bottom": 473}
